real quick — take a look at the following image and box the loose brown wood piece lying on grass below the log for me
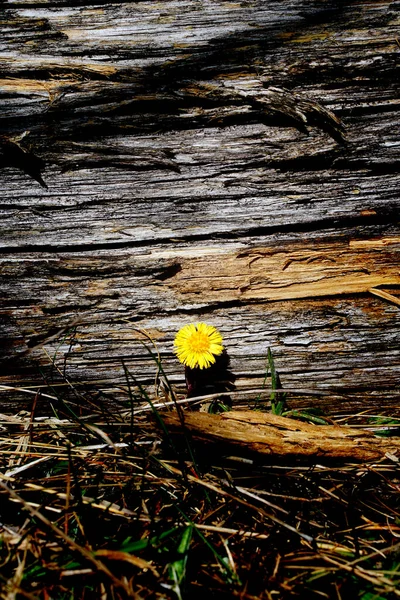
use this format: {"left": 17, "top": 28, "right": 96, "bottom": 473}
{"left": 162, "top": 411, "right": 400, "bottom": 461}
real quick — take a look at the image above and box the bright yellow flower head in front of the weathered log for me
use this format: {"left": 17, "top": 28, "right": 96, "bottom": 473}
{"left": 174, "top": 323, "right": 224, "bottom": 369}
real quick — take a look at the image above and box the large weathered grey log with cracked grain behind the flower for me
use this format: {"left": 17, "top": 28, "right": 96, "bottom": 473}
{"left": 0, "top": 0, "right": 400, "bottom": 410}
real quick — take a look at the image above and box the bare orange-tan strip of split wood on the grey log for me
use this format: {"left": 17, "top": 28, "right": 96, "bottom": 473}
{"left": 167, "top": 237, "right": 400, "bottom": 302}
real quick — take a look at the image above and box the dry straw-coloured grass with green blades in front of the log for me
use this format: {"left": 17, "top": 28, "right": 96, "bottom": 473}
{"left": 0, "top": 354, "right": 400, "bottom": 600}
